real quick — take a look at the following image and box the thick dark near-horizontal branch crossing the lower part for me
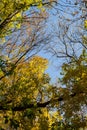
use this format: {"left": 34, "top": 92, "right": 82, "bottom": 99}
{"left": 0, "top": 92, "right": 84, "bottom": 111}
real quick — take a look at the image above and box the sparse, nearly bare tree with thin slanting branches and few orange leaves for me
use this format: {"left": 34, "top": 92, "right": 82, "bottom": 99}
{"left": 0, "top": 8, "right": 49, "bottom": 80}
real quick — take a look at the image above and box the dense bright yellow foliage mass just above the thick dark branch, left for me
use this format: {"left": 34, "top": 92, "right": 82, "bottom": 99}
{"left": 1, "top": 56, "right": 48, "bottom": 102}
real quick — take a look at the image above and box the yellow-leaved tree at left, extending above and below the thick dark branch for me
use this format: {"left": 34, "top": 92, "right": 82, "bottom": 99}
{"left": 0, "top": 56, "right": 49, "bottom": 129}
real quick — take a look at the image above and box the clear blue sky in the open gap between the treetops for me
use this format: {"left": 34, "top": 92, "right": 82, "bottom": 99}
{"left": 39, "top": 0, "right": 85, "bottom": 83}
